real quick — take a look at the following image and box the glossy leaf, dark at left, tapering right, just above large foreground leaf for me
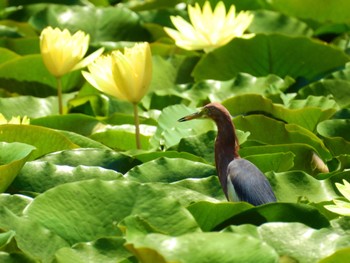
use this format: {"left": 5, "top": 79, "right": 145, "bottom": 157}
{"left": 11, "top": 161, "right": 122, "bottom": 193}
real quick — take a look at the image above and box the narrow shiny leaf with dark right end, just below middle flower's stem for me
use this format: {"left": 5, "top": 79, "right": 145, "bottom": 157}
{"left": 36, "top": 148, "right": 140, "bottom": 174}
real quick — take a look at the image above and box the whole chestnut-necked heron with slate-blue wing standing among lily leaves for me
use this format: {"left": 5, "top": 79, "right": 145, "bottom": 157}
{"left": 178, "top": 102, "right": 277, "bottom": 206}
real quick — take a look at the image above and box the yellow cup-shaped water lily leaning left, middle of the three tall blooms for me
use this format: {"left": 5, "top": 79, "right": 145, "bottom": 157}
{"left": 82, "top": 42, "right": 152, "bottom": 104}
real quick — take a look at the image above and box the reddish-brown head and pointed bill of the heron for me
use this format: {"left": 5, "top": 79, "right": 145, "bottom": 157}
{"left": 178, "top": 102, "right": 230, "bottom": 122}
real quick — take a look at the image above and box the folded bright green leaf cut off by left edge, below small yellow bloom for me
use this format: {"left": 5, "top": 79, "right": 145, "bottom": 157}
{"left": 0, "top": 143, "right": 35, "bottom": 193}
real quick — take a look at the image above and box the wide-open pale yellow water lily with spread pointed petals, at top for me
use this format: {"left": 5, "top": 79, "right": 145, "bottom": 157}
{"left": 164, "top": 1, "right": 253, "bottom": 52}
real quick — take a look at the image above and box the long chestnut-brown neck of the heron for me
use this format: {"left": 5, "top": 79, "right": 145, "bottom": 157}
{"left": 214, "top": 115, "right": 239, "bottom": 197}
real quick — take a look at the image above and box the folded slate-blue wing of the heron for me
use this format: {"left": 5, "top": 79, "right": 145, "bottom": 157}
{"left": 227, "top": 159, "right": 276, "bottom": 205}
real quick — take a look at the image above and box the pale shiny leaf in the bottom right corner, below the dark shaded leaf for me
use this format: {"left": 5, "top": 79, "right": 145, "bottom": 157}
{"left": 228, "top": 222, "right": 350, "bottom": 262}
